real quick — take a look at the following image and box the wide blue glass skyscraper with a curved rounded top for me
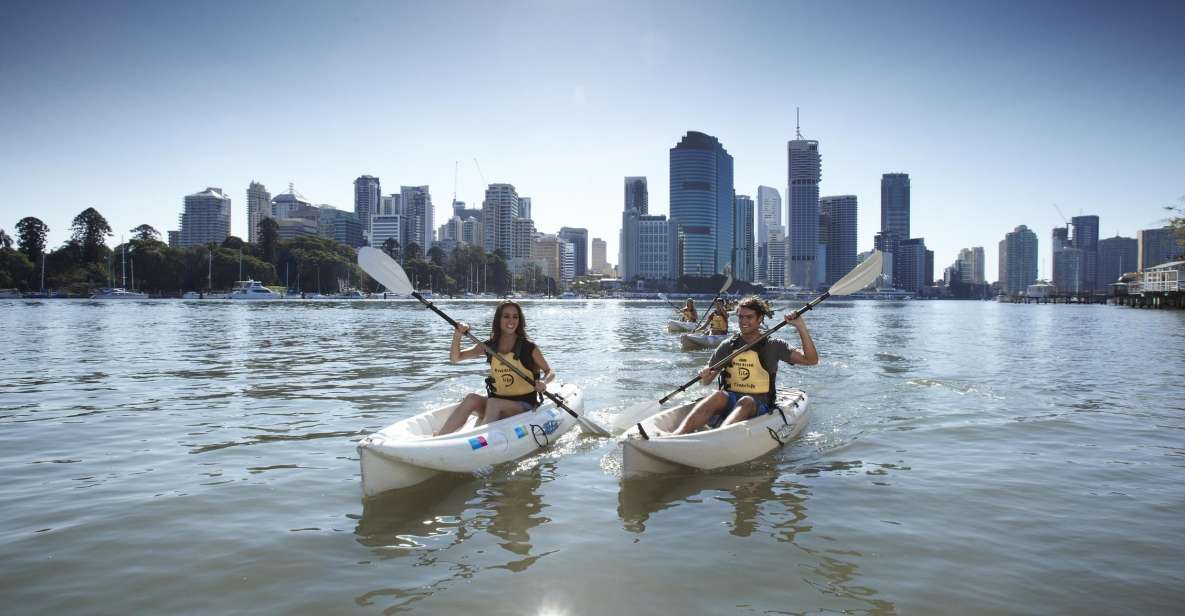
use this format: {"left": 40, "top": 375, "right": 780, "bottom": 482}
{"left": 671, "top": 130, "right": 736, "bottom": 276}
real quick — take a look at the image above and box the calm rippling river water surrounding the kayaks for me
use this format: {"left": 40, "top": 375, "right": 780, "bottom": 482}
{"left": 0, "top": 296, "right": 1185, "bottom": 615}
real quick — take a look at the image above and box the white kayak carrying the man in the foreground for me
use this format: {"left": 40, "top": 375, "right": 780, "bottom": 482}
{"left": 622, "top": 390, "right": 807, "bottom": 477}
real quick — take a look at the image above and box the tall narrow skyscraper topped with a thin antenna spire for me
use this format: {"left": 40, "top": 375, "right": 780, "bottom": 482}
{"left": 786, "top": 129, "right": 822, "bottom": 289}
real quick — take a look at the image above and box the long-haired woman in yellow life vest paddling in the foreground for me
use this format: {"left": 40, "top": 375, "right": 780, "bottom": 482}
{"left": 436, "top": 301, "right": 556, "bottom": 435}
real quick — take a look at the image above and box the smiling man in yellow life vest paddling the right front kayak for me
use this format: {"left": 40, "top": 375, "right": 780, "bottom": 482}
{"left": 671, "top": 296, "right": 819, "bottom": 435}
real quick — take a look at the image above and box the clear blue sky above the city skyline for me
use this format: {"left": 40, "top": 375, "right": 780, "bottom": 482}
{"left": 0, "top": 1, "right": 1185, "bottom": 280}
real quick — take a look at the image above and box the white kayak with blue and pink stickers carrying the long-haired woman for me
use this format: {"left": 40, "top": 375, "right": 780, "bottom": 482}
{"left": 358, "top": 383, "right": 584, "bottom": 496}
